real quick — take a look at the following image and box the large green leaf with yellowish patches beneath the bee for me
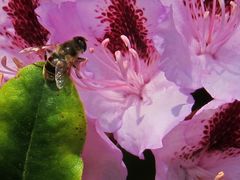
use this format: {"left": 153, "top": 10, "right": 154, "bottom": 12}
{"left": 0, "top": 62, "right": 86, "bottom": 180}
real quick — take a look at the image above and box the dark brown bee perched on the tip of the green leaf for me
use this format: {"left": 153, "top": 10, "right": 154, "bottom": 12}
{"left": 23, "top": 36, "right": 87, "bottom": 89}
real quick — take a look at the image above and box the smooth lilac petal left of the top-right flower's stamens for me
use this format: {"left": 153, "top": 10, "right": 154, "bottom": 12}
{"left": 155, "top": 0, "right": 206, "bottom": 89}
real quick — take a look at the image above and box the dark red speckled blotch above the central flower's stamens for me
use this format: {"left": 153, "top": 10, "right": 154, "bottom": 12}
{"left": 96, "top": 0, "right": 154, "bottom": 63}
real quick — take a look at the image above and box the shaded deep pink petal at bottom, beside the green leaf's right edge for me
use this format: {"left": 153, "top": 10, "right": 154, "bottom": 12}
{"left": 82, "top": 120, "right": 127, "bottom": 180}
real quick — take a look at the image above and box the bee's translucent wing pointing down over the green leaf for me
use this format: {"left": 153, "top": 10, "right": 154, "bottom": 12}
{"left": 55, "top": 61, "right": 67, "bottom": 89}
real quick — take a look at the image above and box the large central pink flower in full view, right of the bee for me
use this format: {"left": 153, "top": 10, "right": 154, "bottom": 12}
{"left": 37, "top": 0, "right": 191, "bottom": 156}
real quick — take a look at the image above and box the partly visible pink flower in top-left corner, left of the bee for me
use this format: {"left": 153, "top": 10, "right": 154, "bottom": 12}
{"left": 0, "top": 0, "right": 49, "bottom": 83}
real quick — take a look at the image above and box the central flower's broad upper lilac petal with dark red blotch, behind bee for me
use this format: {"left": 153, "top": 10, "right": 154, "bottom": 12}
{"left": 37, "top": 0, "right": 165, "bottom": 61}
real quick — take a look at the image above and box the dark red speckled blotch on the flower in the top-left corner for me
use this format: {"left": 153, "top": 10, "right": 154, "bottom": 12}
{"left": 2, "top": 0, "right": 49, "bottom": 48}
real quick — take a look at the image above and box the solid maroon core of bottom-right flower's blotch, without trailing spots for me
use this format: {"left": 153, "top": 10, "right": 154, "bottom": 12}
{"left": 196, "top": 101, "right": 240, "bottom": 156}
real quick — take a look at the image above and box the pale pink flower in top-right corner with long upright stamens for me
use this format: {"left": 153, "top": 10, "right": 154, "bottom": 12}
{"left": 160, "top": 0, "right": 240, "bottom": 100}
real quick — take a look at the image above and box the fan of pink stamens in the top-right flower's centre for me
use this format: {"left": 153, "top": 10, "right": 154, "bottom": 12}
{"left": 183, "top": 0, "right": 240, "bottom": 57}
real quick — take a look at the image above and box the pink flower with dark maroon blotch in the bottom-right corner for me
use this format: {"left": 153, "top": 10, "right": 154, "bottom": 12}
{"left": 154, "top": 101, "right": 240, "bottom": 180}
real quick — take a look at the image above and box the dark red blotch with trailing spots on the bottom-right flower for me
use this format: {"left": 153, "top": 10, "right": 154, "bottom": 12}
{"left": 175, "top": 101, "right": 240, "bottom": 162}
